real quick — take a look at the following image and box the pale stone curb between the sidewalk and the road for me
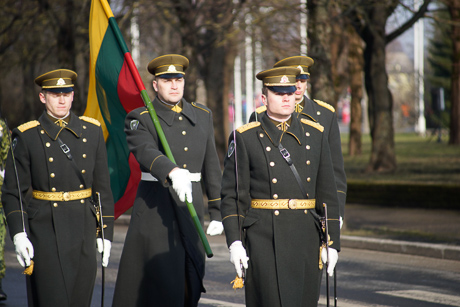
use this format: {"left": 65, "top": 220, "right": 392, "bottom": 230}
{"left": 340, "top": 235, "right": 460, "bottom": 261}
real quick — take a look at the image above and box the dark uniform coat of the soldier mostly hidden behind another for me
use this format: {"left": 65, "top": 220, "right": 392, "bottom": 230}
{"left": 249, "top": 96, "right": 347, "bottom": 218}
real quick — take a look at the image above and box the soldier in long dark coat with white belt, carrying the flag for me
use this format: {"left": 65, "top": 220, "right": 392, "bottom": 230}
{"left": 113, "top": 55, "right": 223, "bottom": 307}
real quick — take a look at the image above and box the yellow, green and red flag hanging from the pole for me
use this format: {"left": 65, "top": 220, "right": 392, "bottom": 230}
{"left": 84, "top": 0, "right": 145, "bottom": 218}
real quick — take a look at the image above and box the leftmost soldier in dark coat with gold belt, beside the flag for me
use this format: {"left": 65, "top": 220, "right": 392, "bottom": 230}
{"left": 2, "top": 69, "right": 113, "bottom": 306}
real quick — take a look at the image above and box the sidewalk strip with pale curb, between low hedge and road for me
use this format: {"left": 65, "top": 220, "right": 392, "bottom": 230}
{"left": 341, "top": 204, "right": 460, "bottom": 261}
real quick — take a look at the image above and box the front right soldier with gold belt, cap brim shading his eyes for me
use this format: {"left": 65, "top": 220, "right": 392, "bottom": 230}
{"left": 221, "top": 67, "right": 340, "bottom": 307}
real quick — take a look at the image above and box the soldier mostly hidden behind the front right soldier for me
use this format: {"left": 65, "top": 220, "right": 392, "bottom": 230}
{"left": 250, "top": 56, "right": 347, "bottom": 228}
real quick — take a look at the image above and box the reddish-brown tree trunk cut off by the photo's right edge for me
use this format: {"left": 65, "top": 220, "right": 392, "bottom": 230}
{"left": 449, "top": 0, "right": 460, "bottom": 145}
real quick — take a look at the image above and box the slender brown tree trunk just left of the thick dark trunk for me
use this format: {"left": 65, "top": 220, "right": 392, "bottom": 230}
{"left": 347, "top": 27, "right": 364, "bottom": 156}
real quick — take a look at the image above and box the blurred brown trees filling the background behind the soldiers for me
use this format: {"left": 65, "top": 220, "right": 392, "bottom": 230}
{"left": 0, "top": 0, "right": 460, "bottom": 172}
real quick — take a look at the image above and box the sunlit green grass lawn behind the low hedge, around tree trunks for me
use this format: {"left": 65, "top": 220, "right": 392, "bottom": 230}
{"left": 342, "top": 133, "right": 460, "bottom": 186}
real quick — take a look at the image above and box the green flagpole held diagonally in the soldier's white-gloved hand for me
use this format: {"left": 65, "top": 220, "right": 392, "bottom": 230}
{"left": 100, "top": 0, "right": 213, "bottom": 258}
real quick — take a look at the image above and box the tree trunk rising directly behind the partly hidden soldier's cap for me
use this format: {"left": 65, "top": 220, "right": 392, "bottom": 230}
{"left": 307, "top": 0, "right": 337, "bottom": 107}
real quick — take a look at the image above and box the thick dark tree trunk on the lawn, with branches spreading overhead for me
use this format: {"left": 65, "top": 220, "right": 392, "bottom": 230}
{"left": 364, "top": 4, "right": 396, "bottom": 172}
